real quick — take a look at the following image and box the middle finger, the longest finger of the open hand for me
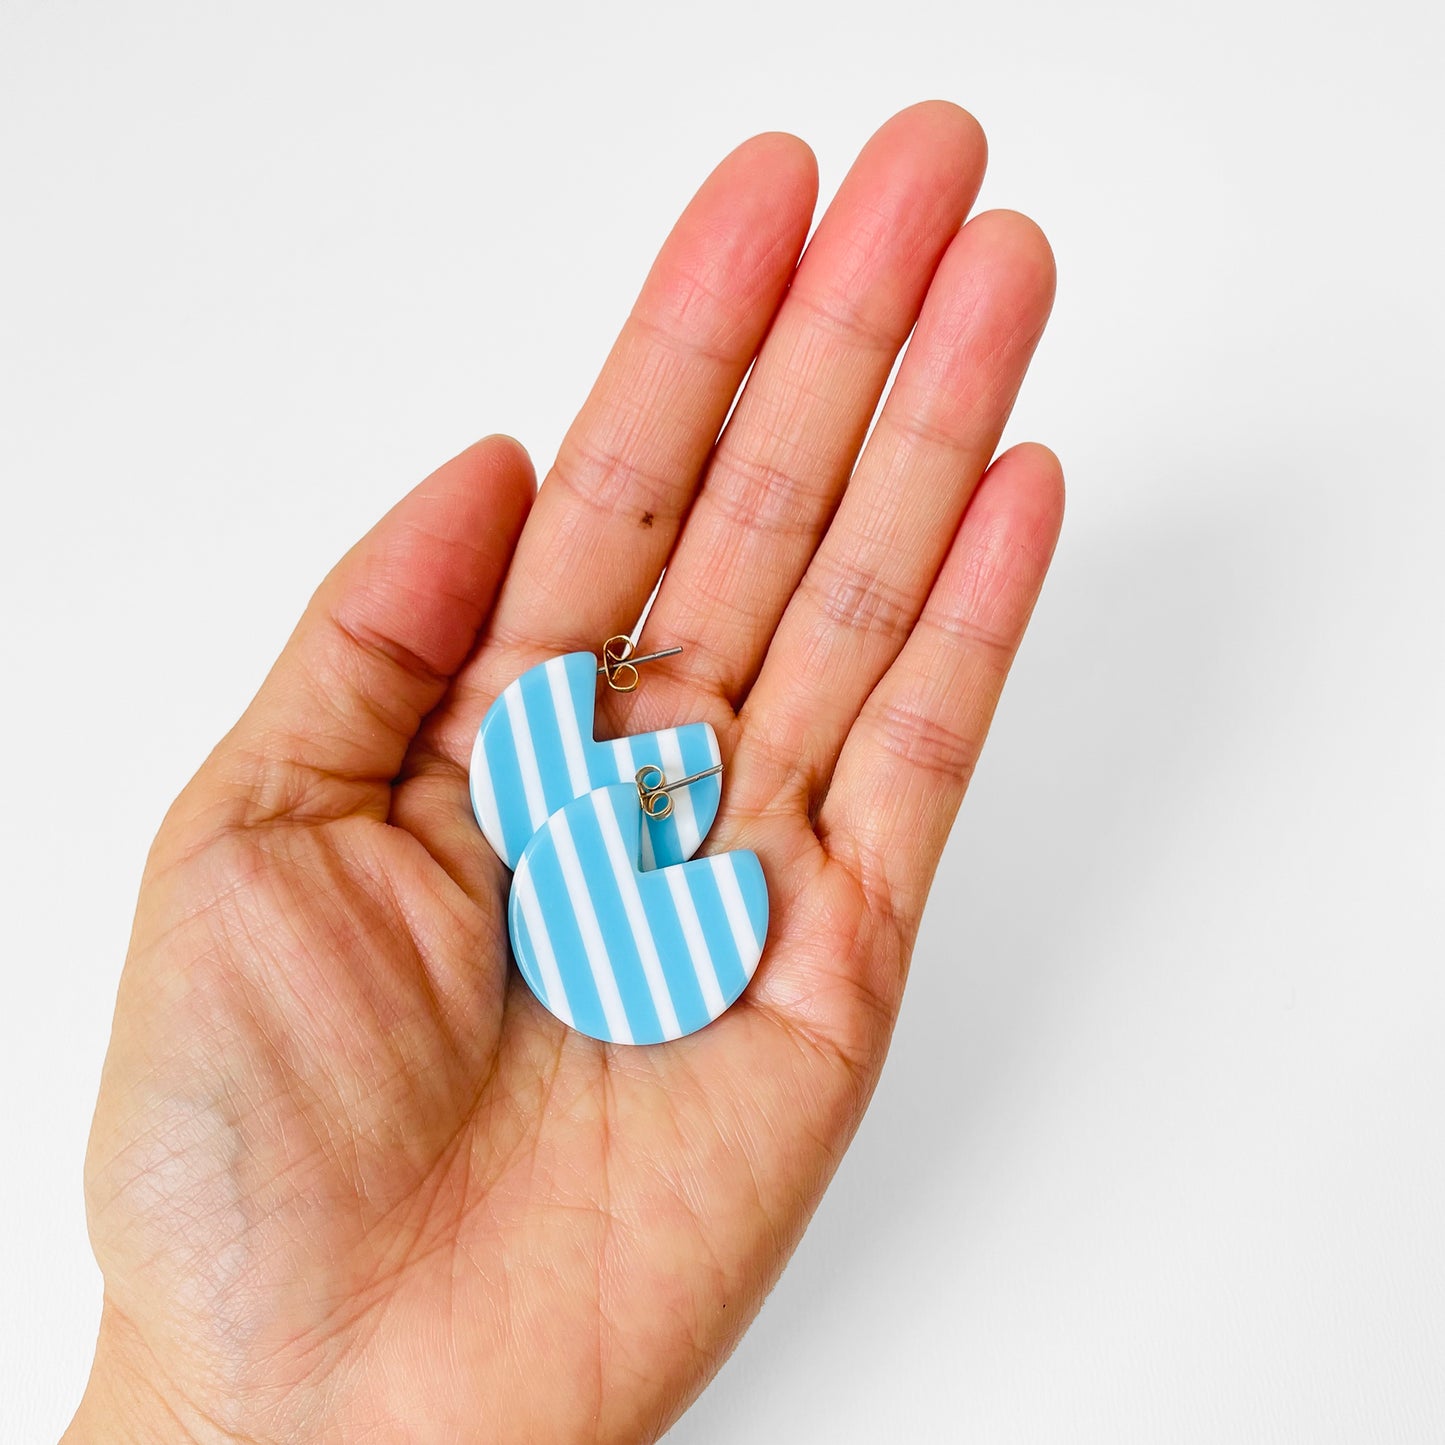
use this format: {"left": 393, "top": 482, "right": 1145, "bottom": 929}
{"left": 647, "top": 101, "right": 985, "bottom": 707}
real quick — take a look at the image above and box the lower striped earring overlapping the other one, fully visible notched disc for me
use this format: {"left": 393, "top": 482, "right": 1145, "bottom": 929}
{"left": 507, "top": 763, "right": 767, "bottom": 1043}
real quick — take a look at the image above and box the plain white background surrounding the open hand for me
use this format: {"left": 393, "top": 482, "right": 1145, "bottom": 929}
{"left": 0, "top": 0, "right": 1445, "bottom": 1445}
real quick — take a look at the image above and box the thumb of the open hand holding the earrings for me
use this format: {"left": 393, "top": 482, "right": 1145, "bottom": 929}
{"left": 212, "top": 436, "right": 536, "bottom": 821}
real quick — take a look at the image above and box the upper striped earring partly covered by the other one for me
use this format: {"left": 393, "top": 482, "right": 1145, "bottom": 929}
{"left": 471, "top": 636, "right": 721, "bottom": 868}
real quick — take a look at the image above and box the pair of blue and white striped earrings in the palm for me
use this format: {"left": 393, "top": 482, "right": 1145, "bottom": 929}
{"left": 471, "top": 637, "right": 767, "bottom": 1043}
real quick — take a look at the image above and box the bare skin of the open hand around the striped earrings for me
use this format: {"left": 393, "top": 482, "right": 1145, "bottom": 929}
{"left": 66, "top": 103, "right": 1062, "bottom": 1442}
